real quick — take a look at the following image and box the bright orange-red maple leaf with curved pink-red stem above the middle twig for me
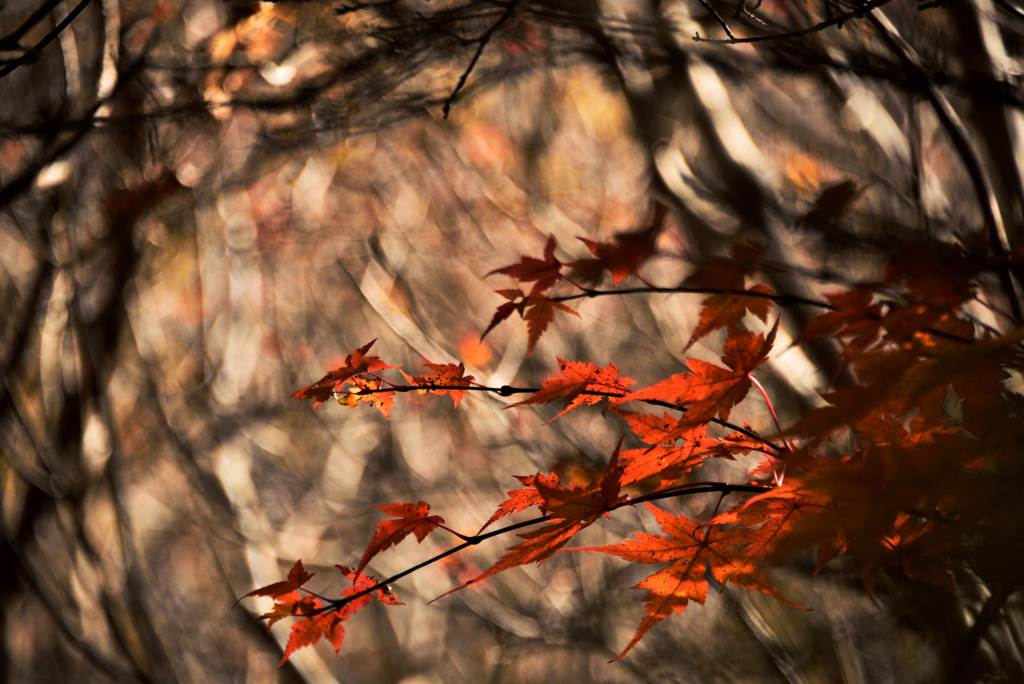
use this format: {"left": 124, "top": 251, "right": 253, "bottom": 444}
{"left": 615, "top": 320, "right": 778, "bottom": 425}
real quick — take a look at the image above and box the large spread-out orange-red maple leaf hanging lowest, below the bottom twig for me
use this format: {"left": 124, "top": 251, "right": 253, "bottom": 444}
{"left": 572, "top": 504, "right": 795, "bottom": 660}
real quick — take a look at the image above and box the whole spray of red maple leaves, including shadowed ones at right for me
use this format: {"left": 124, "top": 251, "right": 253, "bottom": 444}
{"left": 250, "top": 232, "right": 1024, "bottom": 659}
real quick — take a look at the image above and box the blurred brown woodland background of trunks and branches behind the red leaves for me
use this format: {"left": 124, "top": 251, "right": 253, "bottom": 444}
{"left": 0, "top": 0, "right": 1024, "bottom": 684}
